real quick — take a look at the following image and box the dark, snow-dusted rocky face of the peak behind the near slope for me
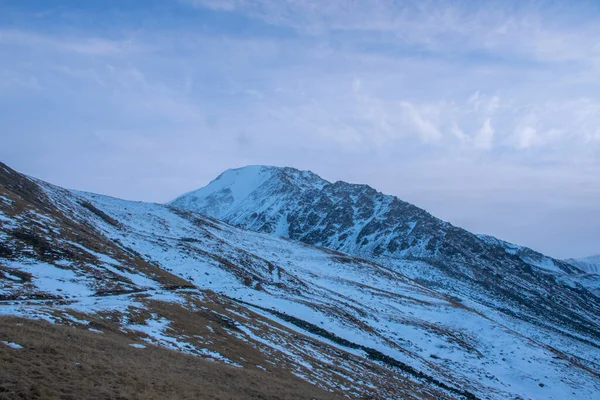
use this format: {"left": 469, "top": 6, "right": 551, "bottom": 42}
{"left": 171, "top": 167, "right": 600, "bottom": 341}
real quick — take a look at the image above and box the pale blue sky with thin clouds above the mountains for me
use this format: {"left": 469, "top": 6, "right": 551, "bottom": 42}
{"left": 0, "top": 0, "right": 600, "bottom": 258}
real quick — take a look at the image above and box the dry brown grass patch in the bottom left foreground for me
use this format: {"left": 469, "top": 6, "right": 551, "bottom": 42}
{"left": 0, "top": 317, "right": 340, "bottom": 400}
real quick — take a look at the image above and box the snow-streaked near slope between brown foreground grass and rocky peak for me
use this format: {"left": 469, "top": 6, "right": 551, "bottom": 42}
{"left": 0, "top": 166, "right": 600, "bottom": 399}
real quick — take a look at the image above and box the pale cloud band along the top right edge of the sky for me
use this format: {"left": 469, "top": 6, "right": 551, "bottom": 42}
{"left": 185, "top": 0, "right": 600, "bottom": 66}
